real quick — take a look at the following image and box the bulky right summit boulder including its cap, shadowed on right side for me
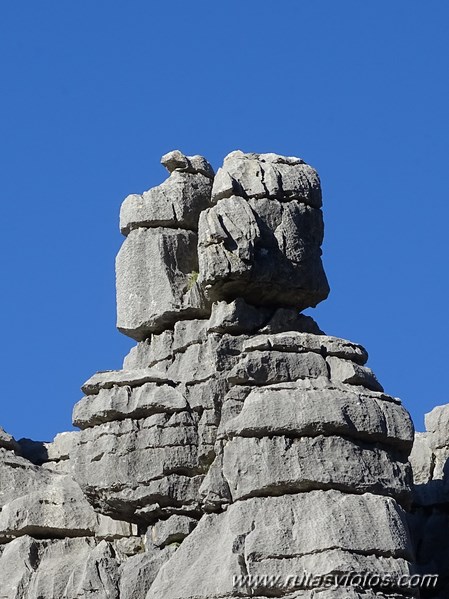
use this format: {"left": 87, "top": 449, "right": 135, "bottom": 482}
{"left": 198, "top": 152, "right": 329, "bottom": 310}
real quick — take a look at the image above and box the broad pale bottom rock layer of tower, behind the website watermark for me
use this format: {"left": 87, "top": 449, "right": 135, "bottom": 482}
{"left": 147, "top": 491, "right": 411, "bottom": 599}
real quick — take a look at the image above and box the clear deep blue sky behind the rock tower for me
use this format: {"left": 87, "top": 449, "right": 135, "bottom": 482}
{"left": 0, "top": 0, "right": 449, "bottom": 440}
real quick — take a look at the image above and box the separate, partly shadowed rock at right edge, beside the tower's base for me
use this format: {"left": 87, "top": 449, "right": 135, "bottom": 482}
{"left": 409, "top": 404, "right": 449, "bottom": 597}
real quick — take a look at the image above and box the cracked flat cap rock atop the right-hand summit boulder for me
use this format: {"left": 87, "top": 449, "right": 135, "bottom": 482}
{"left": 212, "top": 150, "right": 321, "bottom": 208}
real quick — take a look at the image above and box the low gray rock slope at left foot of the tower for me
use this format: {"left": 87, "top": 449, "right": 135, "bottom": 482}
{"left": 0, "top": 431, "right": 143, "bottom": 599}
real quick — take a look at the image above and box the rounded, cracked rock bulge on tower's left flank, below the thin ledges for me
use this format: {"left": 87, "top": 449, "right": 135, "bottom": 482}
{"left": 73, "top": 412, "right": 203, "bottom": 521}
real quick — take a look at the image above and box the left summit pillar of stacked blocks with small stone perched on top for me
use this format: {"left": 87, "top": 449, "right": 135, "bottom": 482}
{"left": 116, "top": 152, "right": 214, "bottom": 340}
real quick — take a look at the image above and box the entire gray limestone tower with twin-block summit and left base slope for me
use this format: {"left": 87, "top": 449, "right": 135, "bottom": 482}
{"left": 0, "top": 151, "right": 414, "bottom": 599}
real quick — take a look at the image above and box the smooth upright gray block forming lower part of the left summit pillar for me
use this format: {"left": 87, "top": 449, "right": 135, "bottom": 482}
{"left": 116, "top": 227, "right": 208, "bottom": 341}
